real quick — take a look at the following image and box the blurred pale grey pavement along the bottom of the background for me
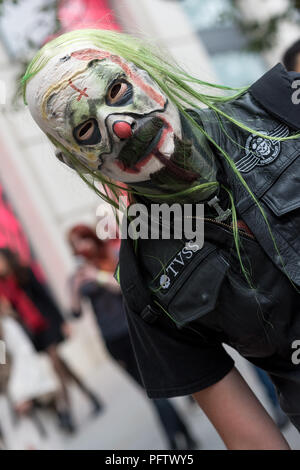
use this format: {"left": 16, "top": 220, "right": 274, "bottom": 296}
{"left": 0, "top": 313, "right": 300, "bottom": 450}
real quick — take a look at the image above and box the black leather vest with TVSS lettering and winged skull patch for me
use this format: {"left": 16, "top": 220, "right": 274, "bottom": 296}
{"left": 120, "top": 64, "right": 300, "bottom": 358}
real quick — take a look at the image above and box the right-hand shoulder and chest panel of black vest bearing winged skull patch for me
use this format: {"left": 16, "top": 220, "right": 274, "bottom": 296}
{"left": 198, "top": 64, "right": 300, "bottom": 286}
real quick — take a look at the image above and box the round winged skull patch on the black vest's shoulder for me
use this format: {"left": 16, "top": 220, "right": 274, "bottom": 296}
{"left": 236, "top": 124, "right": 289, "bottom": 173}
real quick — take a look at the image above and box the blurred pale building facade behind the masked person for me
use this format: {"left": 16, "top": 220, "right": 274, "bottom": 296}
{"left": 0, "top": 0, "right": 300, "bottom": 306}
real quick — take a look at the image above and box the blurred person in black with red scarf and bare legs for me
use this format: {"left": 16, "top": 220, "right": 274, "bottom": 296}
{"left": 0, "top": 248, "right": 102, "bottom": 432}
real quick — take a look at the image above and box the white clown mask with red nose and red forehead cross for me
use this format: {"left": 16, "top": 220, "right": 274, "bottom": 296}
{"left": 26, "top": 44, "right": 181, "bottom": 183}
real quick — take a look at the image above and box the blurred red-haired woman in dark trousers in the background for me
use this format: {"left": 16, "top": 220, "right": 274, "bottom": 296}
{"left": 68, "top": 225, "right": 196, "bottom": 449}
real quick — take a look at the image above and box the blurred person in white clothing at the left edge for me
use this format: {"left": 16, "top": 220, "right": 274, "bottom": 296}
{"left": 0, "top": 297, "right": 55, "bottom": 449}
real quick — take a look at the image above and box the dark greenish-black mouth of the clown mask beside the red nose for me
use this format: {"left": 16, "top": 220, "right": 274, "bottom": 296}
{"left": 118, "top": 117, "right": 166, "bottom": 170}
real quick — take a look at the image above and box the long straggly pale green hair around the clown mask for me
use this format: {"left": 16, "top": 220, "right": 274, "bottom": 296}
{"left": 22, "top": 29, "right": 299, "bottom": 286}
